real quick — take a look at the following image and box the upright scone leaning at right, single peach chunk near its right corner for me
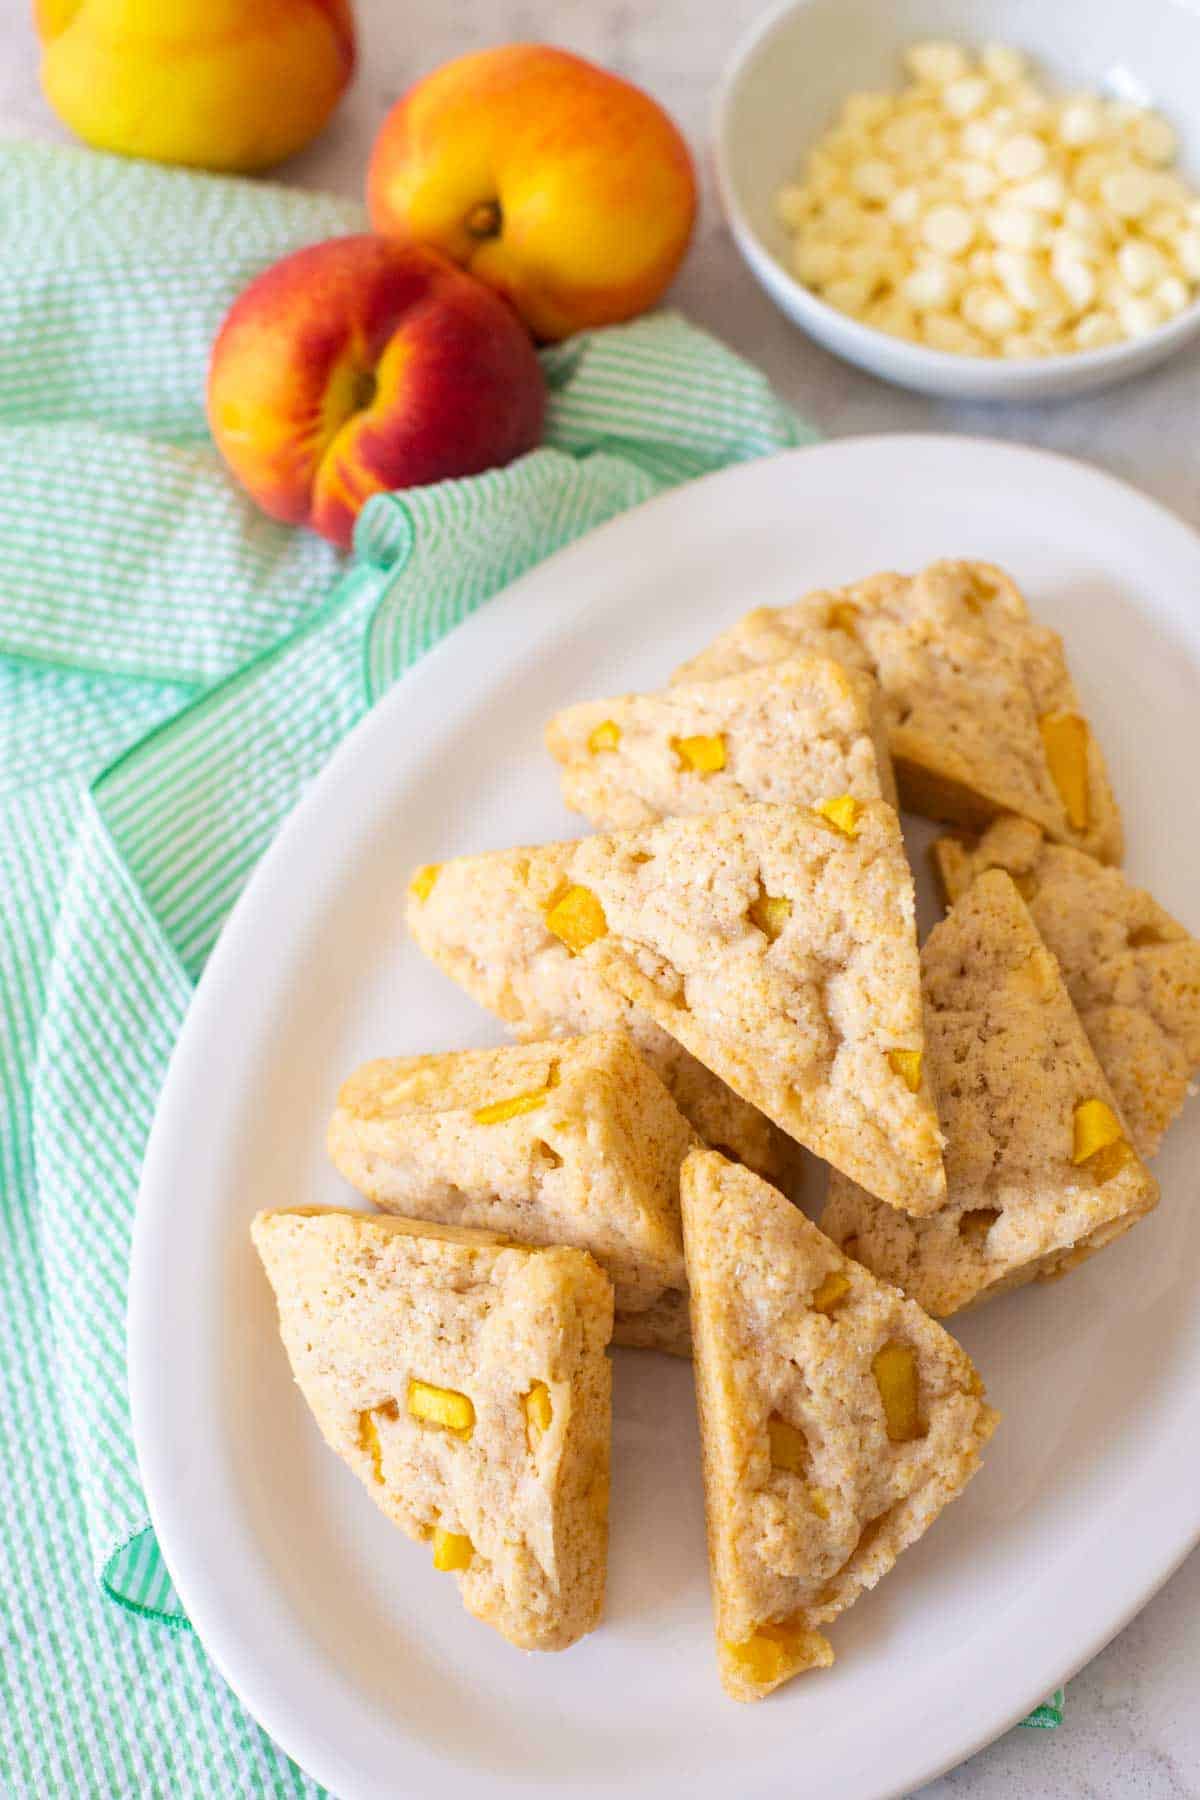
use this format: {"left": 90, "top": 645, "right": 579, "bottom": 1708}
{"left": 820, "top": 867, "right": 1159, "bottom": 1318}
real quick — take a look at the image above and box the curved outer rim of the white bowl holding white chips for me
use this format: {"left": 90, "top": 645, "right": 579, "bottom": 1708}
{"left": 711, "top": 0, "right": 1200, "bottom": 391}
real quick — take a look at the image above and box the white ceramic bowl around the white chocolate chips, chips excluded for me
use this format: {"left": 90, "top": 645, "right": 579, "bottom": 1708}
{"left": 714, "top": 0, "right": 1200, "bottom": 400}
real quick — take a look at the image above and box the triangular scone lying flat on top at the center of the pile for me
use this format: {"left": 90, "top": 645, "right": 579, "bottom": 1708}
{"left": 460, "top": 797, "right": 946, "bottom": 1213}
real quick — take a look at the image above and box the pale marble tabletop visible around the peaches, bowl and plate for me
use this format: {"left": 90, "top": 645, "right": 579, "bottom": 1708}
{"left": 0, "top": 0, "right": 1200, "bottom": 1800}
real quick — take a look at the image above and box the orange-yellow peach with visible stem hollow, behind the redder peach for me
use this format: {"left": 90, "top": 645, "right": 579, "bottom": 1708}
{"left": 367, "top": 43, "right": 696, "bottom": 338}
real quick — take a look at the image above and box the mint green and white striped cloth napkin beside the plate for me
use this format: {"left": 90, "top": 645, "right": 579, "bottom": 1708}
{"left": 0, "top": 146, "right": 1054, "bottom": 1796}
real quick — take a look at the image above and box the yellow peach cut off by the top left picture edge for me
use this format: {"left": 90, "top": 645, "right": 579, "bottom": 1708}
{"left": 34, "top": 0, "right": 354, "bottom": 169}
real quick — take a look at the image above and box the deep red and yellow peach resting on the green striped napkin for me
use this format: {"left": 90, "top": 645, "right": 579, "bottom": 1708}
{"left": 209, "top": 236, "right": 545, "bottom": 549}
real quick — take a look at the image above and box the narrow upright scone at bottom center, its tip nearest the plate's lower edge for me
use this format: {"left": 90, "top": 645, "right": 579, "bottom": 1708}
{"left": 682, "top": 1150, "right": 997, "bottom": 1699}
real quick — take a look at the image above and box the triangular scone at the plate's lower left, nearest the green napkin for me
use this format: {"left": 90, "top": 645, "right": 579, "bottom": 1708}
{"left": 252, "top": 1208, "right": 612, "bottom": 1651}
